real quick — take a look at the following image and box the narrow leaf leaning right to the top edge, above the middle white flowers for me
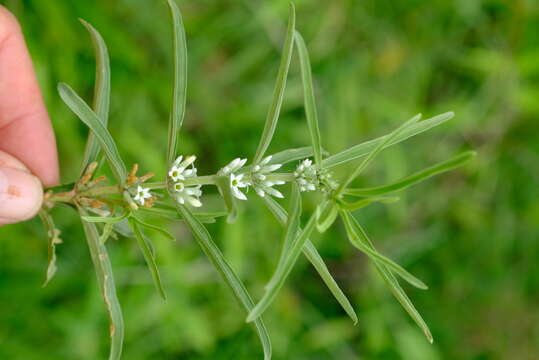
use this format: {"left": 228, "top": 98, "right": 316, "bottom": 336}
{"left": 253, "top": 3, "right": 296, "bottom": 164}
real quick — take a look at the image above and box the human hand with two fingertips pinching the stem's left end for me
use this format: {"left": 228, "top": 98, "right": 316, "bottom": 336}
{"left": 0, "top": 6, "right": 58, "bottom": 225}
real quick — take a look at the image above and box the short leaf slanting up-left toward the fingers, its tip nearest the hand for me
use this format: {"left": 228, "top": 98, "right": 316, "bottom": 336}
{"left": 58, "top": 83, "right": 127, "bottom": 184}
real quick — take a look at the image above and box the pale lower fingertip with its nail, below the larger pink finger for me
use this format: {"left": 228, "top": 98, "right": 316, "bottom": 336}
{"left": 0, "top": 167, "right": 43, "bottom": 224}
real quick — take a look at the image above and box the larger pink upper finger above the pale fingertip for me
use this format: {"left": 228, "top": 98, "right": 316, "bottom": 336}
{"left": 0, "top": 6, "right": 58, "bottom": 186}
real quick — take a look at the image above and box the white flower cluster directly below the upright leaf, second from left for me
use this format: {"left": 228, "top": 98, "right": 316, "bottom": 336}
{"left": 168, "top": 155, "right": 202, "bottom": 207}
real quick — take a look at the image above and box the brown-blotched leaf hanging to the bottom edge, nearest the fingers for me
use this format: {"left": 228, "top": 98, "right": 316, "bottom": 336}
{"left": 79, "top": 208, "right": 124, "bottom": 360}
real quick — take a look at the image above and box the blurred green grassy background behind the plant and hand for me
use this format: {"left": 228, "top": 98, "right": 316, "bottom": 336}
{"left": 0, "top": 0, "right": 539, "bottom": 360}
